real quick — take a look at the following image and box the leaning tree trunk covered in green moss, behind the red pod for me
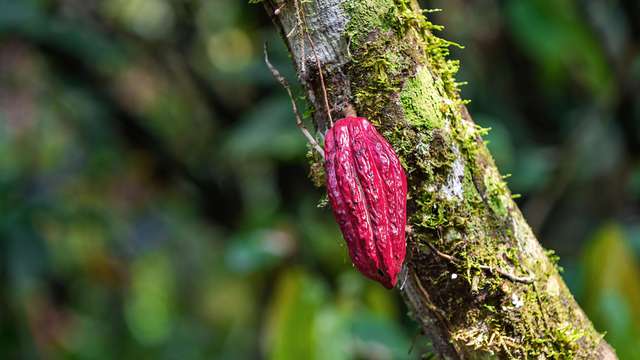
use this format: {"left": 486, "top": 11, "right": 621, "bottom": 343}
{"left": 263, "top": 0, "right": 616, "bottom": 359}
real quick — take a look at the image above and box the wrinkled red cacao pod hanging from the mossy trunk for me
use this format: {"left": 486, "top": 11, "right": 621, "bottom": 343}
{"left": 324, "top": 117, "right": 407, "bottom": 289}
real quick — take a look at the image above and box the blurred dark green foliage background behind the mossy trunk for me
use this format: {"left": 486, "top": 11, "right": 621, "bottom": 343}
{"left": 0, "top": 0, "right": 640, "bottom": 359}
